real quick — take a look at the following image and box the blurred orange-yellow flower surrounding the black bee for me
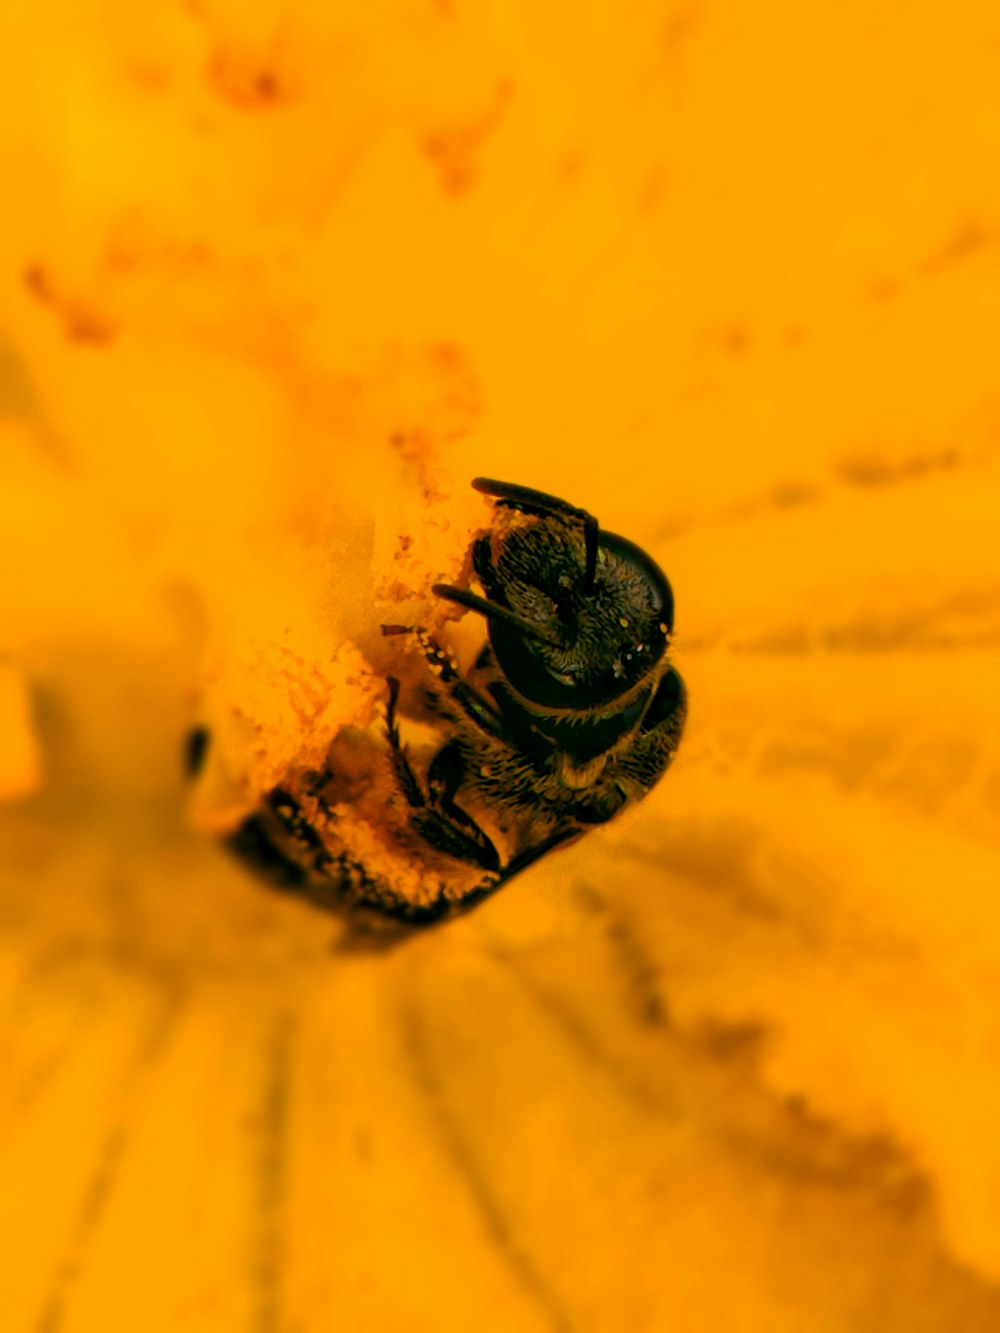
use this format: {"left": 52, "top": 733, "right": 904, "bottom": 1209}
{"left": 0, "top": 0, "right": 1000, "bottom": 1333}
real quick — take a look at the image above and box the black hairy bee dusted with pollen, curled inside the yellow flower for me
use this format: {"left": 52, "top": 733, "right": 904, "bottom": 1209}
{"left": 222, "top": 477, "right": 687, "bottom": 926}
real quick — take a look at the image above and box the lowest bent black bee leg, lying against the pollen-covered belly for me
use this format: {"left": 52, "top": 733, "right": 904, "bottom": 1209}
{"left": 385, "top": 676, "right": 500, "bottom": 873}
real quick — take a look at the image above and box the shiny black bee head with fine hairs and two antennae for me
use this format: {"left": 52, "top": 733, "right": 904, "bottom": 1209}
{"left": 435, "top": 480, "right": 673, "bottom": 710}
